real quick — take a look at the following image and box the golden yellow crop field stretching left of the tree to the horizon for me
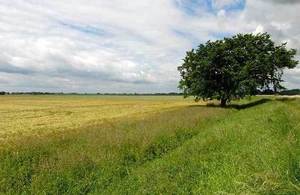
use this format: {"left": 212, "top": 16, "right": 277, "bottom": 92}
{"left": 0, "top": 95, "right": 195, "bottom": 140}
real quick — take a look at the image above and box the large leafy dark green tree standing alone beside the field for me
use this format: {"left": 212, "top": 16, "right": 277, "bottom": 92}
{"left": 178, "top": 33, "right": 298, "bottom": 106}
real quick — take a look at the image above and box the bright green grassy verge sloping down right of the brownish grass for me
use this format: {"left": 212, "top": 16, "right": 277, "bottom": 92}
{"left": 107, "top": 100, "right": 300, "bottom": 194}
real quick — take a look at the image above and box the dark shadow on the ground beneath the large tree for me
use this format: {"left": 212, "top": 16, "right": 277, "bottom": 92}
{"left": 191, "top": 98, "right": 272, "bottom": 110}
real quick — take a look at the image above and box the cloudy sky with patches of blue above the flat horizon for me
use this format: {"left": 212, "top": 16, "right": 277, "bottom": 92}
{"left": 0, "top": 0, "right": 300, "bottom": 93}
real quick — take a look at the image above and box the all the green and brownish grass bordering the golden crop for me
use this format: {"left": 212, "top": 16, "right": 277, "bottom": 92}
{"left": 0, "top": 99, "right": 300, "bottom": 194}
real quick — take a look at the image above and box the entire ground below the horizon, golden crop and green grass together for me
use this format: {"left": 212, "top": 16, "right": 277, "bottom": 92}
{"left": 0, "top": 96, "right": 300, "bottom": 194}
